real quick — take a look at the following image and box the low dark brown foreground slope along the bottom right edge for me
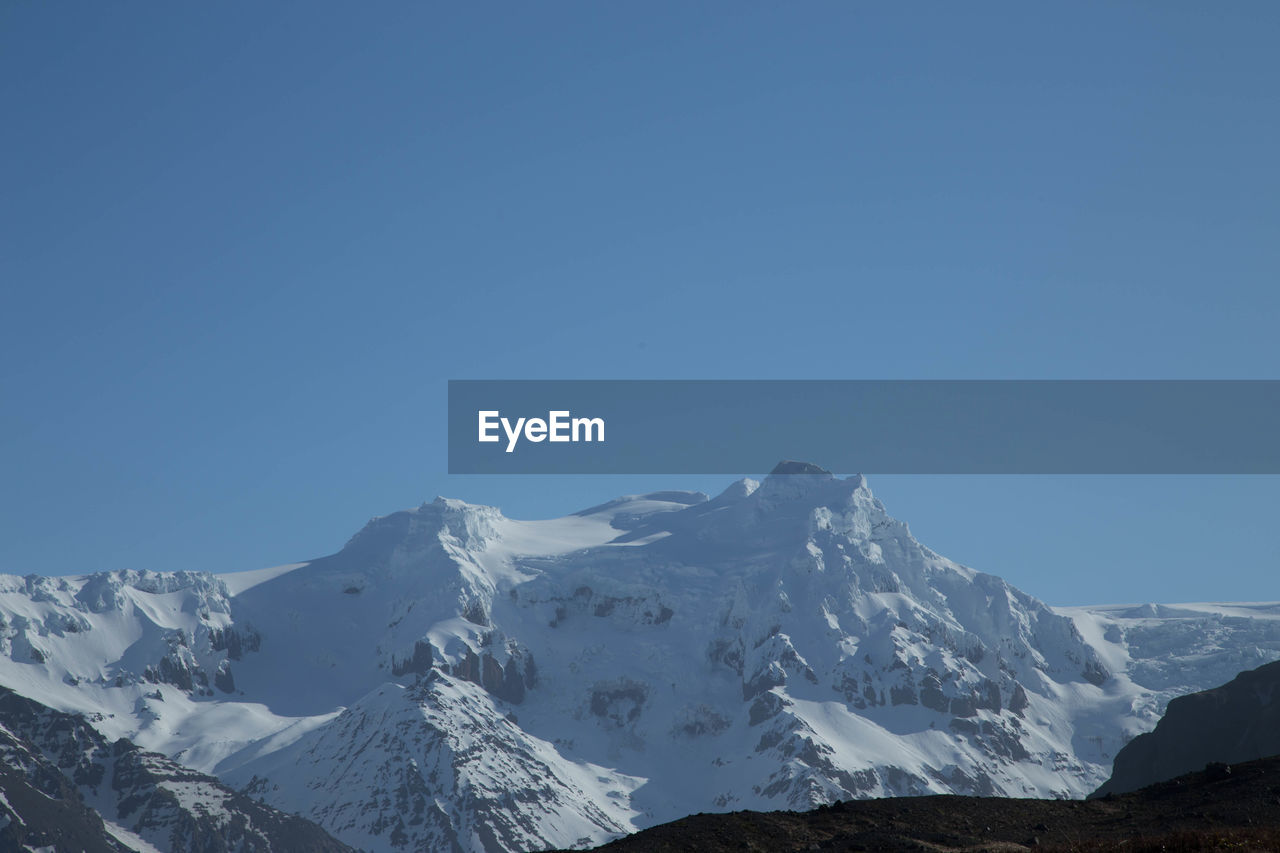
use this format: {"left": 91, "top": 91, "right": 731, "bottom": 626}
{"left": 568, "top": 757, "right": 1280, "bottom": 853}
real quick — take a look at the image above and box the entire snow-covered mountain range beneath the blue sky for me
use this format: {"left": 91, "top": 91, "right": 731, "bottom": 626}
{"left": 0, "top": 464, "right": 1280, "bottom": 850}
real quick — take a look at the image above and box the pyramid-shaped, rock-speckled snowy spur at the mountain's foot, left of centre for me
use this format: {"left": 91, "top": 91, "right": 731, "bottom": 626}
{"left": 236, "top": 671, "right": 639, "bottom": 850}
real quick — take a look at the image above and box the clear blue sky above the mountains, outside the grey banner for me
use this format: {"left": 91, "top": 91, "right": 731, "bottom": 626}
{"left": 0, "top": 0, "right": 1280, "bottom": 603}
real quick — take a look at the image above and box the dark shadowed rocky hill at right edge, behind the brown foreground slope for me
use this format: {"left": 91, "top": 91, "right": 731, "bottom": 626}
{"left": 1094, "top": 662, "right": 1280, "bottom": 795}
